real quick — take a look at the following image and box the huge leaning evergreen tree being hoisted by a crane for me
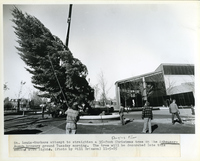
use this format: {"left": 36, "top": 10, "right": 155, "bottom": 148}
{"left": 12, "top": 7, "right": 94, "bottom": 105}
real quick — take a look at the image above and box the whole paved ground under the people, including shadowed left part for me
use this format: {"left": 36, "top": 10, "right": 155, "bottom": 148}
{"left": 4, "top": 109, "right": 195, "bottom": 134}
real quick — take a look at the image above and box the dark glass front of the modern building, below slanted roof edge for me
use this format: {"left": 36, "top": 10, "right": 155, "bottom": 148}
{"left": 119, "top": 73, "right": 166, "bottom": 107}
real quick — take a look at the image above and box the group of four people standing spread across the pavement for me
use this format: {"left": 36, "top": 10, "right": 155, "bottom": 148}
{"left": 65, "top": 99, "right": 183, "bottom": 134}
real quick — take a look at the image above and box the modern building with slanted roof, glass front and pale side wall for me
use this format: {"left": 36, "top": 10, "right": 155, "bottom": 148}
{"left": 115, "top": 64, "right": 195, "bottom": 107}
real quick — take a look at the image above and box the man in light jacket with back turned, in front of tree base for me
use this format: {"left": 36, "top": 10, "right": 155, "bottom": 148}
{"left": 65, "top": 103, "right": 79, "bottom": 134}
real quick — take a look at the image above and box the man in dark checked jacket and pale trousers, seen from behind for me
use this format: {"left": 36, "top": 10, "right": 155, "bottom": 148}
{"left": 142, "top": 101, "right": 153, "bottom": 133}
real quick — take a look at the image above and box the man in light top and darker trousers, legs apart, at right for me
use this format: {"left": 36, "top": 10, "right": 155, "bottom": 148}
{"left": 169, "top": 99, "right": 183, "bottom": 125}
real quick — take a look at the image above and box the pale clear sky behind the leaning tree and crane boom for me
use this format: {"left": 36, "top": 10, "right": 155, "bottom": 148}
{"left": 3, "top": 2, "right": 199, "bottom": 99}
